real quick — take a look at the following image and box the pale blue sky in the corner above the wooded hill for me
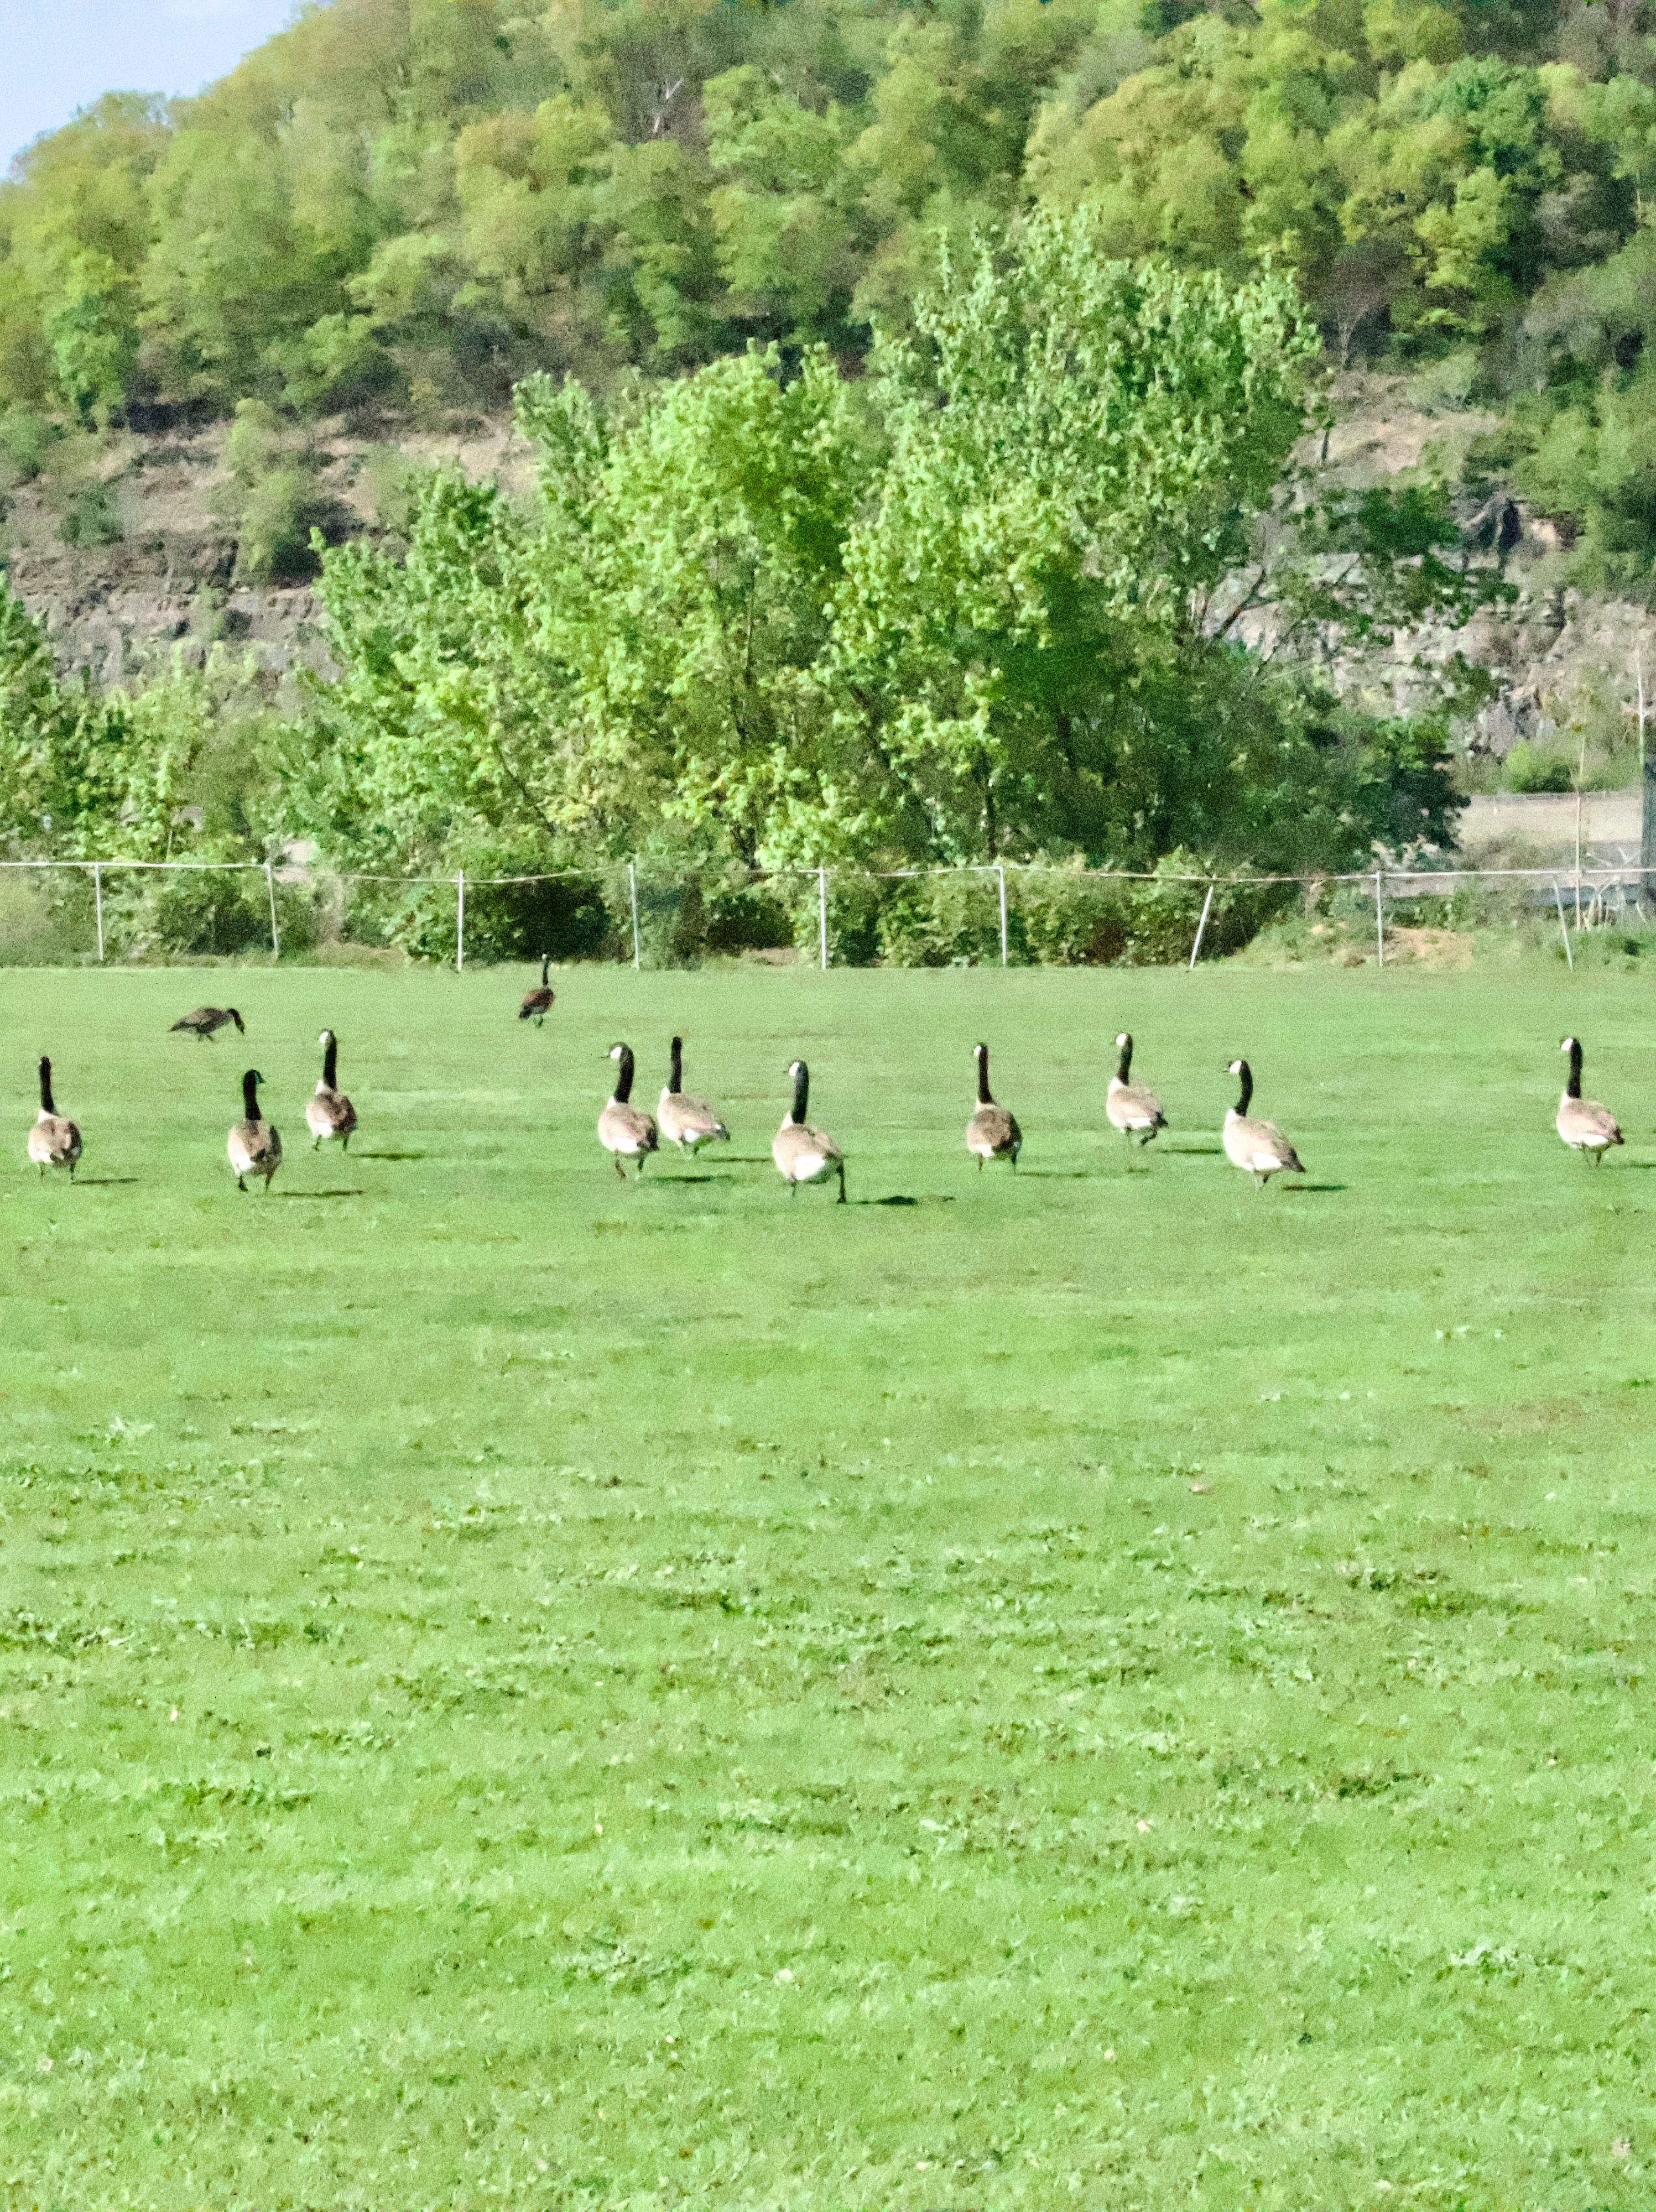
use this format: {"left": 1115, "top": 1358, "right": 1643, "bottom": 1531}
{"left": 0, "top": 0, "right": 294, "bottom": 170}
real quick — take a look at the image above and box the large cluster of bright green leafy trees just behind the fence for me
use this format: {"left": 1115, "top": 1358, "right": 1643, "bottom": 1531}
{"left": 290, "top": 212, "right": 1475, "bottom": 889}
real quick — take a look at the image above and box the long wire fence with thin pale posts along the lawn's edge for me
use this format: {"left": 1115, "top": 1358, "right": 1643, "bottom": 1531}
{"left": 0, "top": 858, "right": 1647, "bottom": 973}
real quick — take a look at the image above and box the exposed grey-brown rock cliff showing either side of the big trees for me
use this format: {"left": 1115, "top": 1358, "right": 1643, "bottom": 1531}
{"left": 0, "top": 376, "right": 1656, "bottom": 781}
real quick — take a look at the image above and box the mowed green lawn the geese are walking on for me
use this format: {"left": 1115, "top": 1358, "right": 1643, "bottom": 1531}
{"left": 0, "top": 962, "right": 1656, "bottom": 2212}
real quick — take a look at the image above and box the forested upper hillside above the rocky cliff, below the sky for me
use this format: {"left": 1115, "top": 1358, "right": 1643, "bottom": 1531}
{"left": 0, "top": 0, "right": 1656, "bottom": 586}
